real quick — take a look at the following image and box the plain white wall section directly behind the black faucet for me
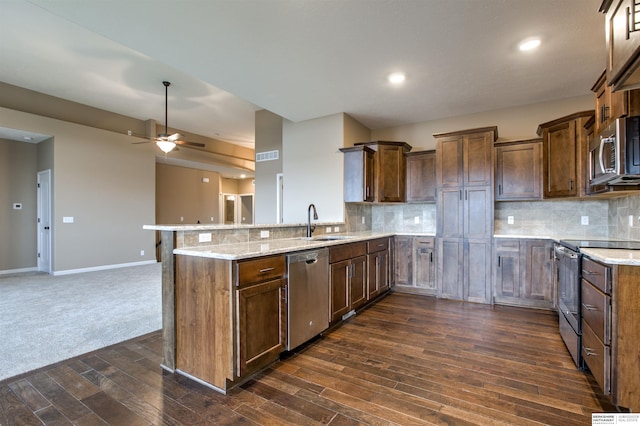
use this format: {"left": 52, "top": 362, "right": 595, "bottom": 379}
{"left": 284, "top": 114, "right": 344, "bottom": 223}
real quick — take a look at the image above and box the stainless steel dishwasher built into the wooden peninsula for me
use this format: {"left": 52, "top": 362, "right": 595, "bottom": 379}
{"left": 287, "top": 248, "right": 329, "bottom": 350}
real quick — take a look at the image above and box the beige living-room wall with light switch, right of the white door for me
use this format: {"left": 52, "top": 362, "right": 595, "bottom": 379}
{"left": 0, "top": 108, "right": 155, "bottom": 273}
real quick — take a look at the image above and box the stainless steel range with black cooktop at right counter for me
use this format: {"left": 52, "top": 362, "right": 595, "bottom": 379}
{"left": 554, "top": 240, "right": 640, "bottom": 369}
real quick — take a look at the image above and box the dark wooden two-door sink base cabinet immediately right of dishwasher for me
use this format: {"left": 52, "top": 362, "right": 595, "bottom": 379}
{"left": 329, "top": 242, "right": 368, "bottom": 323}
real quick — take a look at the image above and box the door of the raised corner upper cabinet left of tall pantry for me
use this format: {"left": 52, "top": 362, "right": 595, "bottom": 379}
{"left": 376, "top": 145, "right": 405, "bottom": 202}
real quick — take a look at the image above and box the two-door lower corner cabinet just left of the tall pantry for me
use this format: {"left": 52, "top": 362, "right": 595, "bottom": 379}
{"left": 394, "top": 235, "right": 436, "bottom": 296}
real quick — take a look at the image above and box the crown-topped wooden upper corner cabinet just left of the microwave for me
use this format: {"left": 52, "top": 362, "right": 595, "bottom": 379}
{"left": 538, "top": 110, "right": 594, "bottom": 198}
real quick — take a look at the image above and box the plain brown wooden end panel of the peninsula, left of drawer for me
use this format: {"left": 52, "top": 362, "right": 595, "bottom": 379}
{"left": 175, "top": 255, "right": 235, "bottom": 390}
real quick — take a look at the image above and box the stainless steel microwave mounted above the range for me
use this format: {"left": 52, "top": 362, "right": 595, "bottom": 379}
{"left": 589, "top": 116, "right": 640, "bottom": 185}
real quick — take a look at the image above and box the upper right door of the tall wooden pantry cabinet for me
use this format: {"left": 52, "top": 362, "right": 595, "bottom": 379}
{"left": 462, "top": 132, "right": 493, "bottom": 186}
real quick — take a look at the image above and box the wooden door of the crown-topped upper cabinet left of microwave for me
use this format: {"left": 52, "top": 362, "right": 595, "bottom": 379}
{"left": 543, "top": 120, "right": 578, "bottom": 198}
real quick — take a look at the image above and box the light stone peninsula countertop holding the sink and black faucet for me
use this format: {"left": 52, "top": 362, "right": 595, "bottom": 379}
{"left": 173, "top": 232, "right": 395, "bottom": 260}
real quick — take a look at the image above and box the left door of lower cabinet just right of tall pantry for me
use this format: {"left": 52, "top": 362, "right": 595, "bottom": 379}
{"left": 494, "top": 240, "right": 520, "bottom": 304}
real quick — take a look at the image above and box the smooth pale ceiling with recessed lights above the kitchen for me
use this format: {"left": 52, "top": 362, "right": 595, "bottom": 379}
{"left": 0, "top": 0, "right": 606, "bottom": 151}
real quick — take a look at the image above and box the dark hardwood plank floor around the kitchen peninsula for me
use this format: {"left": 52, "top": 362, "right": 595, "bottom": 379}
{"left": 0, "top": 293, "right": 615, "bottom": 426}
